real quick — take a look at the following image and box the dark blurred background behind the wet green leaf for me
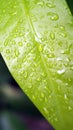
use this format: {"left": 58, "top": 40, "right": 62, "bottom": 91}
{"left": 0, "top": 0, "right": 73, "bottom": 130}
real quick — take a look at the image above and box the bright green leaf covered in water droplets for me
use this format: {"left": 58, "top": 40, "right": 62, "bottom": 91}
{"left": 0, "top": 0, "right": 73, "bottom": 130}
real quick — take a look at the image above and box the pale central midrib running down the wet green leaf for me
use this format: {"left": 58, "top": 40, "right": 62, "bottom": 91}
{"left": 19, "top": 0, "right": 65, "bottom": 126}
